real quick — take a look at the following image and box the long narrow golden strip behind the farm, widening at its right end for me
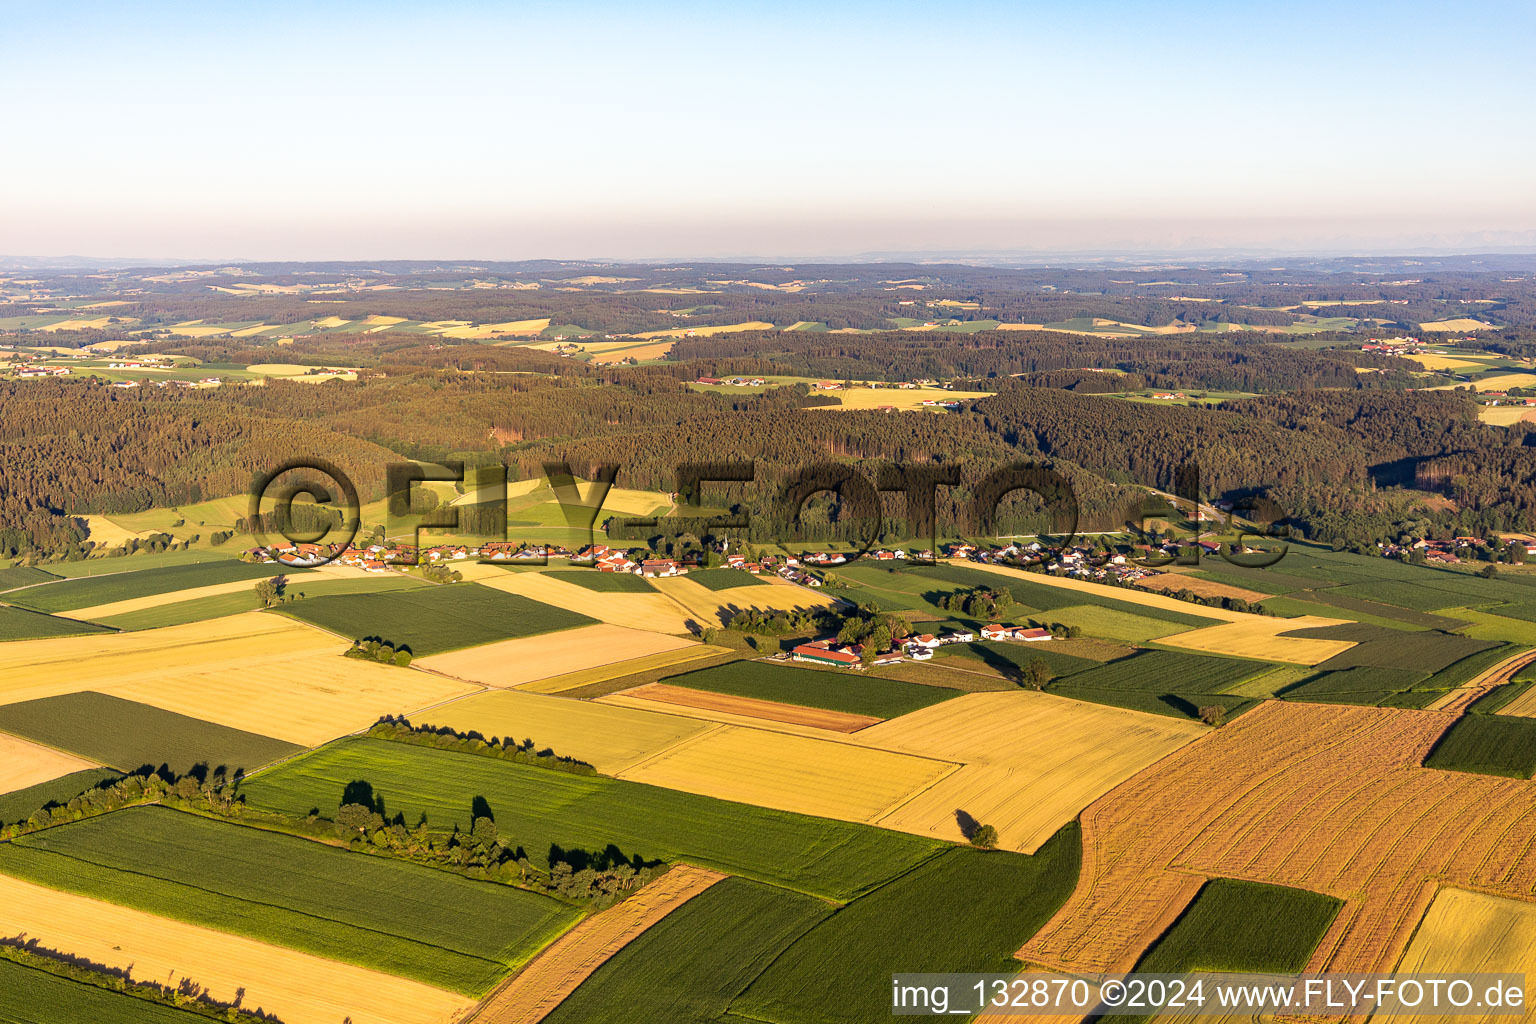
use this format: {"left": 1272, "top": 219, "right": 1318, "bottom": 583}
{"left": 946, "top": 559, "right": 1355, "bottom": 665}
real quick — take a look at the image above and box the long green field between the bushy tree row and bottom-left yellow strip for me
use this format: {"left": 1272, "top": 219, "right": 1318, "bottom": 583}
{"left": 0, "top": 808, "right": 581, "bottom": 995}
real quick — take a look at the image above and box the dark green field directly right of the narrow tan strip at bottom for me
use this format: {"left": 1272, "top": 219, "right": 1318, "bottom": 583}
{"left": 544, "top": 878, "right": 831, "bottom": 1024}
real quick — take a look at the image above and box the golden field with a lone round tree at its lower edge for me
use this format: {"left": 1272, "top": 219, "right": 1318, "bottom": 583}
{"left": 856, "top": 691, "right": 1207, "bottom": 854}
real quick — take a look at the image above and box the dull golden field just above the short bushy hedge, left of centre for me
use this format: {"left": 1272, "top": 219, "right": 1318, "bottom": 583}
{"left": 416, "top": 689, "right": 714, "bottom": 775}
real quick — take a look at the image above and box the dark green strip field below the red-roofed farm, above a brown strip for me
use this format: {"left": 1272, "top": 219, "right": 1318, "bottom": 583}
{"left": 667, "top": 662, "right": 960, "bottom": 718}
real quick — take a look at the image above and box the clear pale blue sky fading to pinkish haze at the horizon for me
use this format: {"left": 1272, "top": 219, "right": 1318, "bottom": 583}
{"left": 0, "top": 0, "right": 1536, "bottom": 259}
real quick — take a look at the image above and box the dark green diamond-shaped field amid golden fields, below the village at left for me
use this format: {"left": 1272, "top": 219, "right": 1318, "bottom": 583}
{"left": 283, "top": 583, "right": 594, "bottom": 657}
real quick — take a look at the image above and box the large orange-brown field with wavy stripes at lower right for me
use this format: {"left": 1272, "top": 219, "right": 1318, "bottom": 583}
{"left": 1018, "top": 702, "right": 1536, "bottom": 972}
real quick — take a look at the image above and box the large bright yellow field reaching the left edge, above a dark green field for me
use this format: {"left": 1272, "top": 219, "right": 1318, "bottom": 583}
{"left": 0, "top": 611, "right": 475, "bottom": 746}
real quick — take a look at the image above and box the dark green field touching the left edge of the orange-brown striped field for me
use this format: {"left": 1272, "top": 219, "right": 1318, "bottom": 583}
{"left": 731, "top": 823, "right": 1081, "bottom": 1024}
